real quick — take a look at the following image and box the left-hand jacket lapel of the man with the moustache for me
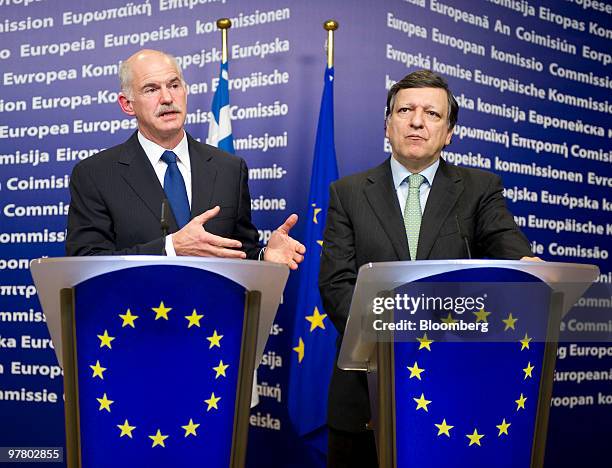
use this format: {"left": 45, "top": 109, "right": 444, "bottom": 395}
{"left": 119, "top": 132, "right": 178, "bottom": 231}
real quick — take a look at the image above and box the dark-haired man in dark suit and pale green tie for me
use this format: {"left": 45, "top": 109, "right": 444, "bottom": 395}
{"left": 319, "top": 70, "right": 531, "bottom": 468}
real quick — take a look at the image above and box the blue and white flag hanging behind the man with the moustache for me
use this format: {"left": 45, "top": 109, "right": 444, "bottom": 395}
{"left": 206, "top": 57, "right": 234, "bottom": 154}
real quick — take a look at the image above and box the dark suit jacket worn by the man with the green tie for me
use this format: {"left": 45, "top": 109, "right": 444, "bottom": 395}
{"left": 319, "top": 160, "right": 531, "bottom": 432}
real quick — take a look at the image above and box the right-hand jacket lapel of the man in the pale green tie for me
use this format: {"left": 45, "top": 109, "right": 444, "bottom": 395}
{"left": 417, "top": 159, "right": 463, "bottom": 260}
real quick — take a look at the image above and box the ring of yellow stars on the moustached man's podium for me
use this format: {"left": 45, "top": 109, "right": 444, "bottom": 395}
{"left": 89, "top": 301, "right": 227, "bottom": 448}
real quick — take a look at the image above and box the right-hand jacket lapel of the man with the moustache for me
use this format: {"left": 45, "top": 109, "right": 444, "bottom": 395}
{"left": 187, "top": 134, "right": 217, "bottom": 218}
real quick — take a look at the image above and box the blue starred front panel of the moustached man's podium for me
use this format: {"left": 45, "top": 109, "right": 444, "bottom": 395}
{"left": 75, "top": 266, "right": 245, "bottom": 468}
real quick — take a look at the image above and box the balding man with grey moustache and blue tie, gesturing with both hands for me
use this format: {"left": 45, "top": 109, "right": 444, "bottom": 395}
{"left": 66, "top": 50, "right": 305, "bottom": 269}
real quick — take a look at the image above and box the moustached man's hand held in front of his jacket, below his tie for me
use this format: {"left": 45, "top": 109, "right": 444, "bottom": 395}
{"left": 172, "top": 206, "right": 246, "bottom": 258}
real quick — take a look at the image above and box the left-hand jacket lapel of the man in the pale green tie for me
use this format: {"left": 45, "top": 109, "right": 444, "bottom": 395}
{"left": 364, "top": 159, "right": 410, "bottom": 260}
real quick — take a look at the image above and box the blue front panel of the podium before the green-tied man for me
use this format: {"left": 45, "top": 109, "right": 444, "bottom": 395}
{"left": 395, "top": 269, "right": 550, "bottom": 468}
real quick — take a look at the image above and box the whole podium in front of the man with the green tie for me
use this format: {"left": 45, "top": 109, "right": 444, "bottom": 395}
{"left": 338, "top": 260, "right": 599, "bottom": 468}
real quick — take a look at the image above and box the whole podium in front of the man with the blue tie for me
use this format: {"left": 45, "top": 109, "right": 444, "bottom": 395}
{"left": 31, "top": 256, "right": 289, "bottom": 468}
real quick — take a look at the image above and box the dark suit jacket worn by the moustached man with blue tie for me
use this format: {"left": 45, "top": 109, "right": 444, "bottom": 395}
{"left": 66, "top": 133, "right": 260, "bottom": 258}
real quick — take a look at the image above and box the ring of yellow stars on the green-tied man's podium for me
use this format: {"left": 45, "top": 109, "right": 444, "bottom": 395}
{"left": 406, "top": 309, "right": 535, "bottom": 446}
